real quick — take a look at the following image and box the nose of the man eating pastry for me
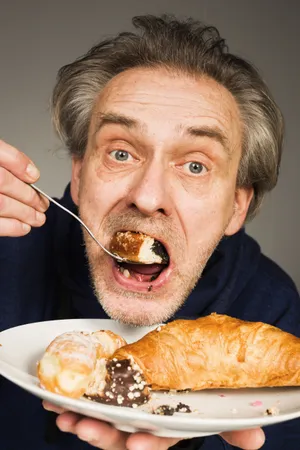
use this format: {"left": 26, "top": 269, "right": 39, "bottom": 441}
{"left": 127, "top": 161, "right": 171, "bottom": 217}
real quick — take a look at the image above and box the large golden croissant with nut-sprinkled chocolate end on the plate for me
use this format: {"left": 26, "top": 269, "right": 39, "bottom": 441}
{"left": 101, "top": 313, "right": 300, "bottom": 407}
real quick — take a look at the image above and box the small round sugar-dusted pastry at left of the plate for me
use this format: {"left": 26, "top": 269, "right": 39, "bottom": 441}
{"left": 37, "top": 330, "right": 126, "bottom": 398}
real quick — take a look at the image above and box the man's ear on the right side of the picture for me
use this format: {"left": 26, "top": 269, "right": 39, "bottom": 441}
{"left": 225, "top": 187, "right": 253, "bottom": 236}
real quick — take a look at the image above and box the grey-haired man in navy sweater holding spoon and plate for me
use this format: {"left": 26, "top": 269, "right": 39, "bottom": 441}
{"left": 0, "top": 16, "right": 300, "bottom": 450}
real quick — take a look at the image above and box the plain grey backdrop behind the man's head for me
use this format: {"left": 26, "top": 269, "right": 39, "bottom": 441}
{"left": 0, "top": 0, "right": 300, "bottom": 288}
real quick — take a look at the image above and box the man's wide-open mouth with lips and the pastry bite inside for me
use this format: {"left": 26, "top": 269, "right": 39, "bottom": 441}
{"left": 110, "top": 231, "right": 170, "bottom": 292}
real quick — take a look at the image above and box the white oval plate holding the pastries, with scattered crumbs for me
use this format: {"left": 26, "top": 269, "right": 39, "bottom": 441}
{"left": 0, "top": 319, "right": 300, "bottom": 438}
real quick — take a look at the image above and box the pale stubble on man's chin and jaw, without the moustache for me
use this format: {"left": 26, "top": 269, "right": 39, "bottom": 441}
{"left": 84, "top": 233, "right": 223, "bottom": 326}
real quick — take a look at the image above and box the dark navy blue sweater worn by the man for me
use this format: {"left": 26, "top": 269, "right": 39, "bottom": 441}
{"left": 0, "top": 186, "right": 300, "bottom": 450}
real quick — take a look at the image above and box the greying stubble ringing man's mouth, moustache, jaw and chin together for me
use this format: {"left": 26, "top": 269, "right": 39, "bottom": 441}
{"left": 80, "top": 197, "right": 227, "bottom": 326}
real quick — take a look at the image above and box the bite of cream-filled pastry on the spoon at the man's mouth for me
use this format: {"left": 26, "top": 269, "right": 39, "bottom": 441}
{"left": 109, "top": 231, "right": 169, "bottom": 264}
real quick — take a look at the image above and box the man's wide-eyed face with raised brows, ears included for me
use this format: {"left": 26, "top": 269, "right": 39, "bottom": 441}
{"left": 72, "top": 69, "right": 251, "bottom": 325}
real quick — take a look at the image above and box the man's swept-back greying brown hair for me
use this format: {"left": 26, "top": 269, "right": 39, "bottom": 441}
{"left": 52, "top": 15, "right": 284, "bottom": 220}
